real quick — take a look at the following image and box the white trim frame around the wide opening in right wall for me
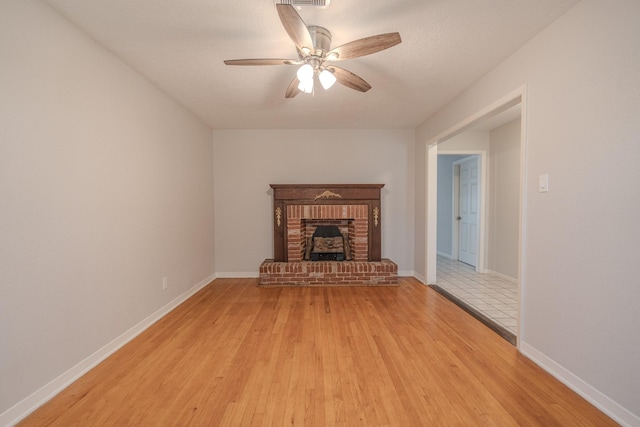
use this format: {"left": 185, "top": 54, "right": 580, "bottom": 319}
{"left": 424, "top": 84, "right": 527, "bottom": 349}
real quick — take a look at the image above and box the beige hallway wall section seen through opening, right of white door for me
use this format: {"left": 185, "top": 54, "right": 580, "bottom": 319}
{"left": 487, "top": 119, "right": 521, "bottom": 279}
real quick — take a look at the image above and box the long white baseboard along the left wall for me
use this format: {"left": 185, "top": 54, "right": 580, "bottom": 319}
{"left": 0, "top": 274, "right": 216, "bottom": 426}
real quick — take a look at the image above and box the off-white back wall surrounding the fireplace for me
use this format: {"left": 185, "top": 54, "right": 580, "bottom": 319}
{"left": 214, "top": 129, "right": 415, "bottom": 277}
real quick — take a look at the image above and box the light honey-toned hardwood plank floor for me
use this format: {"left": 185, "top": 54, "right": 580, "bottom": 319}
{"left": 22, "top": 278, "right": 616, "bottom": 426}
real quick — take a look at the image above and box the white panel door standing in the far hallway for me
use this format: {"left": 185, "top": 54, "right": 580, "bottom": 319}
{"left": 457, "top": 156, "right": 480, "bottom": 267}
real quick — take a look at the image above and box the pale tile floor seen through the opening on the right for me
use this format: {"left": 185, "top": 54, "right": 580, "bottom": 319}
{"left": 436, "top": 256, "right": 518, "bottom": 336}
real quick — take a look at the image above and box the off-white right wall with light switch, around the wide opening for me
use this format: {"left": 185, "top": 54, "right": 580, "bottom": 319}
{"left": 416, "top": 0, "right": 640, "bottom": 425}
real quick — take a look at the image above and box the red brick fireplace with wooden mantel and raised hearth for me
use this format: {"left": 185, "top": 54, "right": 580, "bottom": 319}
{"left": 260, "top": 184, "right": 397, "bottom": 286}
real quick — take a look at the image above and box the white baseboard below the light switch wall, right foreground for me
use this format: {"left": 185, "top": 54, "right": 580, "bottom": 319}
{"left": 520, "top": 342, "right": 640, "bottom": 427}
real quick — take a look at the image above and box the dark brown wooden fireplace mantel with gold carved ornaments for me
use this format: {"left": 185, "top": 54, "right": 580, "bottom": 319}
{"left": 270, "top": 184, "right": 384, "bottom": 262}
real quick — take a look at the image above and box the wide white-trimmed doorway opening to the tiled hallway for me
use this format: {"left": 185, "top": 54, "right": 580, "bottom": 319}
{"left": 426, "top": 88, "right": 526, "bottom": 345}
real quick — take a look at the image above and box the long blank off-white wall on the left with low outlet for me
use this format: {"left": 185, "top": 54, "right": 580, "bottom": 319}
{"left": 0, "top": 0, "right": 214, "bottom": 425}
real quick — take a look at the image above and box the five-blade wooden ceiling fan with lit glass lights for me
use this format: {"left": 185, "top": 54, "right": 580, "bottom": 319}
{"left": 224, "top": 4, "right": 402, "bottom": 98}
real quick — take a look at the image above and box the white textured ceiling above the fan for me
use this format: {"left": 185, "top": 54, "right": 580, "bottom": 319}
{"left": 45, "top": 0, "right": 578, "bottom": 129}
